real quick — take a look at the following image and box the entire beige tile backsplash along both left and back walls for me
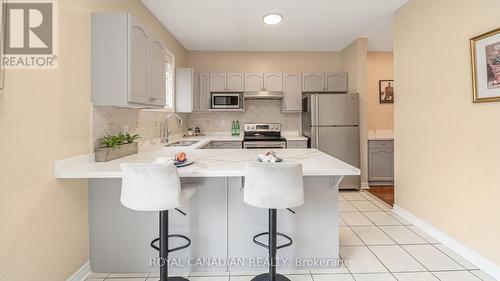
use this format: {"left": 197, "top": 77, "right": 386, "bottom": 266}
{"left": 92, "top": 100, "right": 301, "bottom": 147}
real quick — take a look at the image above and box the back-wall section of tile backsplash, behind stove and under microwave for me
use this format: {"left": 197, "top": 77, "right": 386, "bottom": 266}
{"left": 187, "top": 100, "right": 302, "bottom": 132}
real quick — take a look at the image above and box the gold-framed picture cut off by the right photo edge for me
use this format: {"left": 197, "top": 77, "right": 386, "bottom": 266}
{"left": 470, "top": 28, "right": 500, "bottom": 103}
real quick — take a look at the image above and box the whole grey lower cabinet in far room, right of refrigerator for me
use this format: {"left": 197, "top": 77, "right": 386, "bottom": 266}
{"left": 368, "top": 140, "right": 394, "bottom": 186}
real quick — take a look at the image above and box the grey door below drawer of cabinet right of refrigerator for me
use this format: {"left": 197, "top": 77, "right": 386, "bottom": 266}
{"left": 368, "top": 148, "right": 394, "bottom": 182}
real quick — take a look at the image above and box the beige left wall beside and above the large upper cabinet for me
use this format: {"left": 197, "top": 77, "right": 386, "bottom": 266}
{"left": 0, "top": 0, "right": 185, "bottom": 281}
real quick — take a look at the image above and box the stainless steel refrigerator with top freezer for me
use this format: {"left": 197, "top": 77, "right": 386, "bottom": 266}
{"left": 302, "top": 94, "right": 361, "bottom": 190}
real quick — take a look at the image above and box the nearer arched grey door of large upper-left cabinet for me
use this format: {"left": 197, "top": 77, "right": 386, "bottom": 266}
{"left": 128, "top": 18, "right": 149, "bottom": 104}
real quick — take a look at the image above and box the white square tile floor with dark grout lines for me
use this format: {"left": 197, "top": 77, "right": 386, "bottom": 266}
{"left": 87, "top": 191, "right": 494, "bottom": 281}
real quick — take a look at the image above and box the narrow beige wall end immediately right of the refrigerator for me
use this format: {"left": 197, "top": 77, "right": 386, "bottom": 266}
{"left": 341, "top": 38, "right": 368, "bottom": 182}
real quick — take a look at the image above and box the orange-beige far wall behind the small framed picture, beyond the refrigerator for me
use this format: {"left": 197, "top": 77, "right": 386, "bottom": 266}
{"left": 367, "top": 52, "right": 394, "bottom": 130}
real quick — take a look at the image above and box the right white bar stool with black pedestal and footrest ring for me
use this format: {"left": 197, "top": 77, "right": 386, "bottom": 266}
{"left": 243, "top": 162, "right": 304, "bottom": 281}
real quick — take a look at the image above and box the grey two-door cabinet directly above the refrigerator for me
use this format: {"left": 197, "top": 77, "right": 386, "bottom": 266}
{"left": 302, "top": 72, "right": 348, "bottom": 93}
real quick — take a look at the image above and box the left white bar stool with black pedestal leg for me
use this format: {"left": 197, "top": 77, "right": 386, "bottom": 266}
{"left": 120, "top": 163, "right": 196, "bottom": 281}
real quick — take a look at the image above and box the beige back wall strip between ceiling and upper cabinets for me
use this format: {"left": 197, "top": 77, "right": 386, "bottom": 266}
{"left": 187, "top": 51, "right": 341, "bottom": 73}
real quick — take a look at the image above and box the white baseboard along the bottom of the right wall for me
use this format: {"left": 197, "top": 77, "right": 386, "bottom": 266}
{"left": 392, "top": 204, "right": 500, "bottom": 280}
